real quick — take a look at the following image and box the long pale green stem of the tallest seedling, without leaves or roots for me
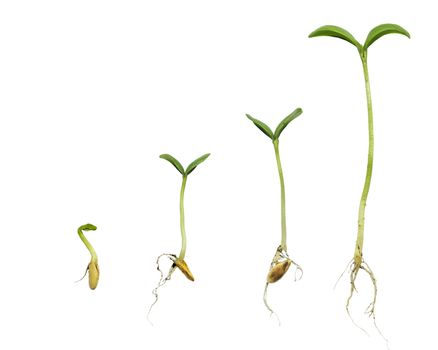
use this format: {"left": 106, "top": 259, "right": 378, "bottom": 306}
{"left": 354, "top": 51, "right": 374, "bottom": 262}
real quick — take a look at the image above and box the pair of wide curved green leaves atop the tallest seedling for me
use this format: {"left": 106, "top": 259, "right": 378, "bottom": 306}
{"left": 309, "top": 23, "right": 411, "bottom": 53}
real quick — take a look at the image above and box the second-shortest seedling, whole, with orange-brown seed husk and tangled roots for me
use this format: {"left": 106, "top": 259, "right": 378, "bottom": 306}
{"left": 148, "top": 153, "right": 210, "bottom": 318}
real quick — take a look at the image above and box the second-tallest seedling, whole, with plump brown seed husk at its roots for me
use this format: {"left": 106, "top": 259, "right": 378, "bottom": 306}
{"left": 246, "top": 108, "right": 303, "bottom": 316}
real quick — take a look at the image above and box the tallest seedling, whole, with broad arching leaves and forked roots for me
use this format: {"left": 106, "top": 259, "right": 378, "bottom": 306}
{"left": 309, "top": 24, "right": 410, "bottom": 328}
